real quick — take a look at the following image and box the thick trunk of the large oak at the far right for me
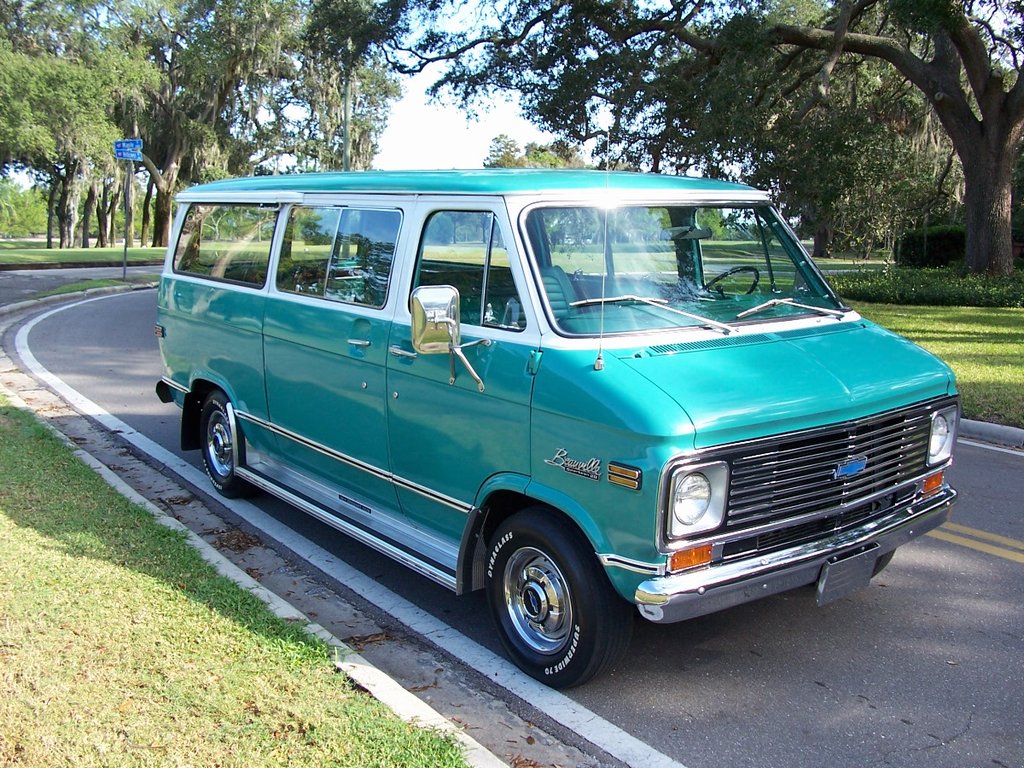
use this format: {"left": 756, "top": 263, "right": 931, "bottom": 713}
{"left": 961, "top": 146, "right": 1016, "bottom": 276}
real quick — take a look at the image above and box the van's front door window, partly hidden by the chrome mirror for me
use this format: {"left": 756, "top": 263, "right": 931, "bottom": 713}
{"left": 413, "top": 211, "right": 526, "bottom": 331}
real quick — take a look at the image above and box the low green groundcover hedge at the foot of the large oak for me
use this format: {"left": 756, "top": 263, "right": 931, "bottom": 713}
{"left": 828, "top": 267, "right": 1024, "bottom": 308}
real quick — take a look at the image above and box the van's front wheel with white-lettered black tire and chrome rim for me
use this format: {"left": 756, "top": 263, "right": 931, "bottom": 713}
{"left": 486, "top": 507, "right": 633, "bottom": 688}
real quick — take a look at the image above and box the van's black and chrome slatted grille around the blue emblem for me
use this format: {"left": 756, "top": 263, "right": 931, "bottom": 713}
{"left": 726, "top": 399, "right": 953, "bottom": 530}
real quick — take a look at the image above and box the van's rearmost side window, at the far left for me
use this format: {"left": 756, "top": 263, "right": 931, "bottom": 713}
{"left": 174, "top": 204, "right": 278, "bottom": 288}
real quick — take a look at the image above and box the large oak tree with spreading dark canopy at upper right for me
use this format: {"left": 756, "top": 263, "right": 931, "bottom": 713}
{"left": 387, "top": 0, "right": 1024, "bottom": 273}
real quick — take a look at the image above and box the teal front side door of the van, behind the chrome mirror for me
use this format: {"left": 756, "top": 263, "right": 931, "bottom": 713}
{"left": 387, "top": 207, "right": 536, "bottom": 542}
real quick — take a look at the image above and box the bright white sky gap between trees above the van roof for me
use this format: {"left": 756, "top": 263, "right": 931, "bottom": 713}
{"left": 374, "top": 73, "right": 555, "bottom": 170}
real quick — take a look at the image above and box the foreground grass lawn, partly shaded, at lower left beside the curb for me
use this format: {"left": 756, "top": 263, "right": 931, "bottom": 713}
{"left": 0, "top": 397, "right": 464, "bottom": 768}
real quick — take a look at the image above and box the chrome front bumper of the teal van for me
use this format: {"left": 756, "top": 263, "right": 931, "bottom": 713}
{"left": 634, "top": 486, "right": 956, "bottom": 624}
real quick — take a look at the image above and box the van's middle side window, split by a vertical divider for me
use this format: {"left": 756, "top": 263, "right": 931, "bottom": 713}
{"left": 276, "top": 206, "right": 401, "bottom": 308}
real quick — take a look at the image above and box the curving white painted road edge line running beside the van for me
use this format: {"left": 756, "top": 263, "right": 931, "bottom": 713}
{"left": 14, "top": 296, "right": 685, "bottom": 768}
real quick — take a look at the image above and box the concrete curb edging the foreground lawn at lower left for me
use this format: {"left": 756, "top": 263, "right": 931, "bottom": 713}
{"left": 0, "top": 385, "right": 508, "bottom": 768}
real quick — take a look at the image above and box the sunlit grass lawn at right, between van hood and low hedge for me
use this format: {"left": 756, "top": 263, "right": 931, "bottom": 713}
{"left": 855, "top": 303, "right": 1024, "bottom": 434}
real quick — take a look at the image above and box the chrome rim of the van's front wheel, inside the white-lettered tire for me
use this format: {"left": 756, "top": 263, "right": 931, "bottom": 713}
{"left": 505, "top": 547, "right": 572, "bottom": 654}
